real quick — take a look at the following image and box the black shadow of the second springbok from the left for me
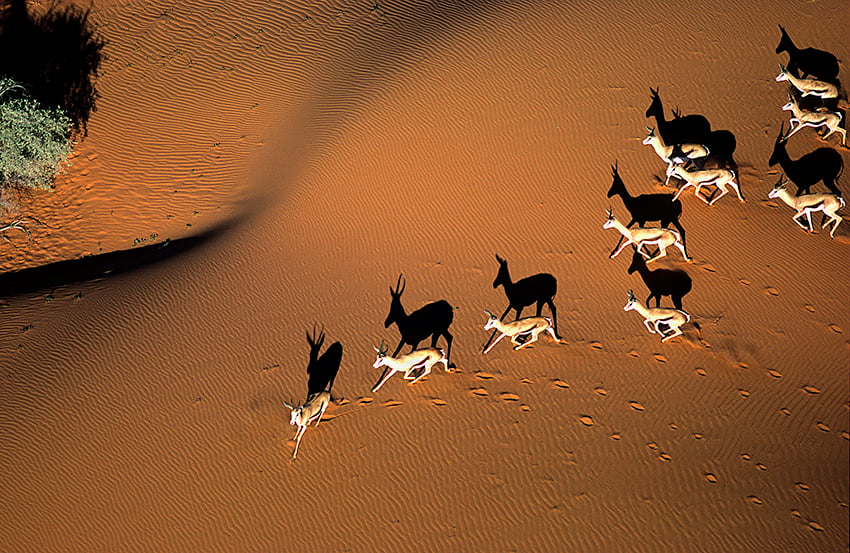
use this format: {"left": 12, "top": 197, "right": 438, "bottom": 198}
{"left": 378, "top": 275, "right": 455, "bottom": 382}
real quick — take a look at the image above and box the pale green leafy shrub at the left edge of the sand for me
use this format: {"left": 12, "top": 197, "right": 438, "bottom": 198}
{"left": 0, "top": 78, "right": 74, "bottom": 190}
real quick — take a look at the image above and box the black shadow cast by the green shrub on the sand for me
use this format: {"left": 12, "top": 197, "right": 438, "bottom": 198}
{"left": 0, "top": 0, "right": 104, "bottom": 134}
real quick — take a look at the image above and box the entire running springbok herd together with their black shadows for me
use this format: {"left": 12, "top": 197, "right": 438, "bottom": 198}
{"left": 286, "top": 26, "right": 847, "bottom": 460}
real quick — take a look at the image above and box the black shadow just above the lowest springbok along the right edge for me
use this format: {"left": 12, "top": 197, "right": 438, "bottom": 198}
{"left": 767, "top": 123, "right": 844, "bottom": 197}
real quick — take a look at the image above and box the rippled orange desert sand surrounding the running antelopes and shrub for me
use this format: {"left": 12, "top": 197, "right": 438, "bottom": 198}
{"left": 0, "top": 0, "right": 850, "bottom": 552}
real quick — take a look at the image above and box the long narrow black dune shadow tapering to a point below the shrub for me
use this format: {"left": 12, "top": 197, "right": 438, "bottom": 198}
{"left": 0, "top": 224, "right": 231, "bottom": 298}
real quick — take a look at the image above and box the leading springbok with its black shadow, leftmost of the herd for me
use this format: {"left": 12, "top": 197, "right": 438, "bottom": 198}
{"left": 284, "top": 327, "right": 342, "bottom": 461}
